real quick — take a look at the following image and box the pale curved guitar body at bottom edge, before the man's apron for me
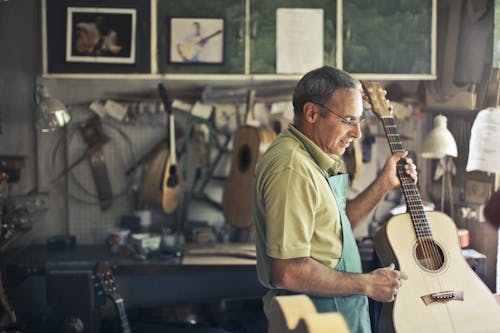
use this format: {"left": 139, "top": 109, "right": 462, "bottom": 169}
{"left": 268, "top": 295, "right": 349, "bottom": 333}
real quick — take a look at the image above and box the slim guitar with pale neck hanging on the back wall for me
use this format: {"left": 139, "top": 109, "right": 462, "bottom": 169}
{"left": 158, "top": 83, "right": 181, "bottom": 214}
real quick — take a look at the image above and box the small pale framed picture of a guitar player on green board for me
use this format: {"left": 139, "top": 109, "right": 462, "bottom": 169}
{"left": 169, "top": 18, "right": 224, "bottom": 64}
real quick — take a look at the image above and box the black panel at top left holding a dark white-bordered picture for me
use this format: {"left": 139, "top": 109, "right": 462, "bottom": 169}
{"left": 42, "top": 0, "right": 151, "bottom": 74}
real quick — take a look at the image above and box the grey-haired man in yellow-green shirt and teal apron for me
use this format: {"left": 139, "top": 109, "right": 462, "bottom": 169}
{"left": 252, "top": 66, "right": 417, "bottom": 333}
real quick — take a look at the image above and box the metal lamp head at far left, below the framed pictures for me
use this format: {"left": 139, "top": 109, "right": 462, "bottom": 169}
{"left": 36, "top": 85, "right": 71, "bottom": 133}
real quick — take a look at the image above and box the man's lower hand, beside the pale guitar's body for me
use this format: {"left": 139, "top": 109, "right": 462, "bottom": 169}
{"left": 366, "top": 264, "right": 408, "bottom": 302}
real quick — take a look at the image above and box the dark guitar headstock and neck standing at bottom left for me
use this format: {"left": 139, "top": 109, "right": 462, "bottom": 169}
{"left": 96, "top": 261, "right": 131, "bottom": 333}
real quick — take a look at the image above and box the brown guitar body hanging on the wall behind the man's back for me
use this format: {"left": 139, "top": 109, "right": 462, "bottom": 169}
{"left": 222, "top": 126, "right": 276, "bottom": 228}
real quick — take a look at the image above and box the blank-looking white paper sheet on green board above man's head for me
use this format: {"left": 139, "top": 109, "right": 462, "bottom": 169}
{"left": 276, "top": 8, "right": 323, "bottom": 74}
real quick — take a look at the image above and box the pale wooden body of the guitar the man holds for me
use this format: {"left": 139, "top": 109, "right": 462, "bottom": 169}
{"left": 375, "top": 211, "right": 500, "bottom": 333}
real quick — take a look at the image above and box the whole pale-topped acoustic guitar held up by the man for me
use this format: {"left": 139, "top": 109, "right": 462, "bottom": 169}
{"left": 362, "top": 81, "right": 500, "bottom": 333}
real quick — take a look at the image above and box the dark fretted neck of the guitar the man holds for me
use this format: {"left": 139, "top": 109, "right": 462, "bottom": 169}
{"left": 382, "top": 116, "right": 432, "bottom": 238}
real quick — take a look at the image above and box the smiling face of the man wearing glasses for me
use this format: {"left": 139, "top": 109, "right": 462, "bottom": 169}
{"left": 313, "top": 89, "right": 363, "bottom": 156}
